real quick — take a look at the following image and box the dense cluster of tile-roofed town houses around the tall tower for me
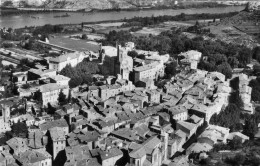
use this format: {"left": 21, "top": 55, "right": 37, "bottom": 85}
{"left": 0, "top": 43, "right": 249, "bottom": 166}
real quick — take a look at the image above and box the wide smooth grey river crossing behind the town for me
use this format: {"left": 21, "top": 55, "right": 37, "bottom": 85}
{"left": 0, "top": 6, "right": 245, "bottom": 28}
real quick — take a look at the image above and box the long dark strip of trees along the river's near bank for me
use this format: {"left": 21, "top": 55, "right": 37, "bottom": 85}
{"left": 122, "top": 12, "right": 238, "bottom": 27}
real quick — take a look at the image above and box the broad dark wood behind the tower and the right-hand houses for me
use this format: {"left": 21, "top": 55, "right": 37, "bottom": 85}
{"left": 102, "top": 30, "right": 252, "bottom": 78}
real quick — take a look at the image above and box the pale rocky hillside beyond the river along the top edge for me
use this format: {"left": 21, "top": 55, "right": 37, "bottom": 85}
{"left": 1, "top": 0, "right": 174, "bottom": 10}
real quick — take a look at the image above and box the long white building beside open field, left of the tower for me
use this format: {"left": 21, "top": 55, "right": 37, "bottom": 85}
{"left": 49, "top": 52, "right": 87, "bottom": 72}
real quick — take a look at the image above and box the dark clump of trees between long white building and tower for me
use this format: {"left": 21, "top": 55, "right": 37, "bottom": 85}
{"left": 60, "top": 59, "right": 99, "bottom": 88}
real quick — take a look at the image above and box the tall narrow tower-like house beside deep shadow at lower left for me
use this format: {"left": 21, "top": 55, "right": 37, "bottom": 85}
{"left": 49, "top": 127, "right": 66, "bottom": 160}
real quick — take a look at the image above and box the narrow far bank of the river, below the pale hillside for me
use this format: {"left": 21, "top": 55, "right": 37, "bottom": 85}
{"left": 0, "top": 2, "right": 245, "bottom": 17}
